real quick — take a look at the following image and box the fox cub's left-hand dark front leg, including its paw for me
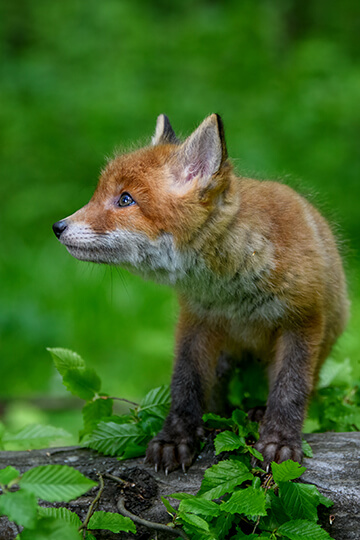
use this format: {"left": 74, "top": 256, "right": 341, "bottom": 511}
{"left": 146, "top": 310, "right": 219, "bottom": 473}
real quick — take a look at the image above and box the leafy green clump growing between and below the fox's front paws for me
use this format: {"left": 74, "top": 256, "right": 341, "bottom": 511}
{"left": 164, "top": 420, "right": 332, "bottom": 540}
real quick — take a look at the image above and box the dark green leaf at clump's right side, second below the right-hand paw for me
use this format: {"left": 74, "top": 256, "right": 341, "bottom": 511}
{"left": 279, "top": 482, "right": 319, "bottom": 521}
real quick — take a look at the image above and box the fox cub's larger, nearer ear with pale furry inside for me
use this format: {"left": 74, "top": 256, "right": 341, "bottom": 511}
{"left": 177, "top": 114, "right": 227, "bottom": 187}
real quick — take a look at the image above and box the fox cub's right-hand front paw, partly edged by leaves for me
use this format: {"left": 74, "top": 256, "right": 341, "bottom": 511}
{"left": 253, "top": 433, "right": 303, "bottom": 470}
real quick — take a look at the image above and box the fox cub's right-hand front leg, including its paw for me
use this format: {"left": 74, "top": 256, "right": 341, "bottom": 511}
{"left": 256, "top": 330, "right": 319, "bottom": 467}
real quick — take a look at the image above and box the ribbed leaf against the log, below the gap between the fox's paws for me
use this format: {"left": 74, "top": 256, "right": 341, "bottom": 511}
{"left": 198, "top": 460, "right": 253, "bottom": 500}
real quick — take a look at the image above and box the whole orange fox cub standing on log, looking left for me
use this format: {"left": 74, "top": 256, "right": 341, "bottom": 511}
{"left": 53, "top": 114, "right": 349, "bottom": 474}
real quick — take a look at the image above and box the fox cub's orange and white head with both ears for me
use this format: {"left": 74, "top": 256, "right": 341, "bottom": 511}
{"left": 53, "top": 114, "right": 231, "bottom": 283}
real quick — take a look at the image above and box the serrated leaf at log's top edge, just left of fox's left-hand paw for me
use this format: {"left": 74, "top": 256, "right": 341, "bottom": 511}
{"left": 87, "top": 422, "right": 146, "bottom": 456}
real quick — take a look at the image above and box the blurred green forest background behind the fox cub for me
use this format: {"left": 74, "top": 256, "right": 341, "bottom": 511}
{"left": 0, "top": 0, "right": 360, "bottom": 434}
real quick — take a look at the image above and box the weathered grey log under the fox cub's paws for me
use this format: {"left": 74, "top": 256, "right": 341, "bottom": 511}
{"left": 0, "top": 433, "right": 360, "bottom": 540}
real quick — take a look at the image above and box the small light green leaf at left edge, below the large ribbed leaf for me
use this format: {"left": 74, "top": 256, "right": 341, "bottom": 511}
{"left": 0, "top": 489, "right": 38, "bottom": 529}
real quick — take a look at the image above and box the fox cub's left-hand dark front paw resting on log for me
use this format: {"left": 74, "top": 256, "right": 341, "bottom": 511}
{"left": 146, "top": 427, "right": 203, "bottom": 474}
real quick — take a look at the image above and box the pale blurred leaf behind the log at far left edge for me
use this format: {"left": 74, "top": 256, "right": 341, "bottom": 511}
{"left": 3, "top": 424, "right": 72, "bottom": 450}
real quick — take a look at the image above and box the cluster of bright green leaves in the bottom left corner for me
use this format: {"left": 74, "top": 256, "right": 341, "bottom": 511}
{"left": 0, "top": 465, "right": 136, "bottom": 540}
